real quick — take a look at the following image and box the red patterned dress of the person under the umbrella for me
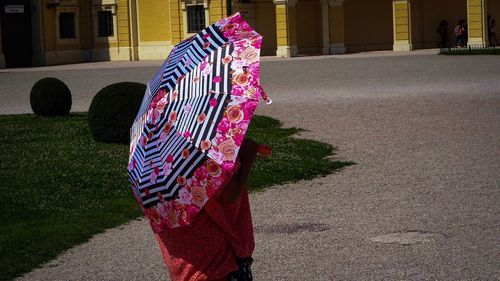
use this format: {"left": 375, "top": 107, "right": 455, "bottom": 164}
{"left": 156, "top": 190, "right": 255, "bottom": 281}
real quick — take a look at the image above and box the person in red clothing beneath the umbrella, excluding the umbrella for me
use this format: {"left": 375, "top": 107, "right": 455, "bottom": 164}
{"left": 156, "top": 139, "right": 270, "bottom": 281}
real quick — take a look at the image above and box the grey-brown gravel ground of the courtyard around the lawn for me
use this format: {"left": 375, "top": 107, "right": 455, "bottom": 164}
{"left": 0, "top": 50, "right": 500, "bottom": 280}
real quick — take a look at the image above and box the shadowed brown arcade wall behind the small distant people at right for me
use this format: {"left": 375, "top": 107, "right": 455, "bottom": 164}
{"left": 411, "top": 0, "right": 467, "bottom": 49}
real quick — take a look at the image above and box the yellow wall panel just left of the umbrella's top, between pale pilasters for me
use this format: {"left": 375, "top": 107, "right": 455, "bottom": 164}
{"left": 137, "top": 0, "right": 171, "bottom": 42}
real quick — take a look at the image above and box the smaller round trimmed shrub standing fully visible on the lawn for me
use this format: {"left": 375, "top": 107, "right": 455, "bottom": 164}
{"left": 30, "top": 77, "right": 71, "bottom": 116}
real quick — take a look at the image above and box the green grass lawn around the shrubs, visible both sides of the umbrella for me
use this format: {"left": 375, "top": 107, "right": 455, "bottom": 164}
{"left": 0, "top": 114, "right": 352, "bottom": 280}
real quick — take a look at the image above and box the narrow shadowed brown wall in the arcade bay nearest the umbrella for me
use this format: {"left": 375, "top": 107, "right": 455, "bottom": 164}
{"left": 297, "top": 0, "right": 323, "bottom": 54}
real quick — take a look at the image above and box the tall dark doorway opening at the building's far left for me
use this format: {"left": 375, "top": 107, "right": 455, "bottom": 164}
{"left": 0, "top": 0, "right": 33, "bottom": 67}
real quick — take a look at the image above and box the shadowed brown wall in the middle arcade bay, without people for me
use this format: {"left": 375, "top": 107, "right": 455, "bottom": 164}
{"left": 344, "top": 0, "right": 393, "bottom": 52}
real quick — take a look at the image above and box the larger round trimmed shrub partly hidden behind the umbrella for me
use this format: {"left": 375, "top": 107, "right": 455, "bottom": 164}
{"left": 88, "top": 82, "right": 146, "bottom": 143}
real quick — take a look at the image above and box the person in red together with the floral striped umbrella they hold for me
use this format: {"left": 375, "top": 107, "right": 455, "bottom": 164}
{"left": 128, "top": 13, "right": 271, "bottom": 281}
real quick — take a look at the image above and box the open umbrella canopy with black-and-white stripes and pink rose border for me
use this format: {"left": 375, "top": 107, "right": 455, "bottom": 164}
{"left": 128, "top": 14, "right": 269, "bottom": 232}
